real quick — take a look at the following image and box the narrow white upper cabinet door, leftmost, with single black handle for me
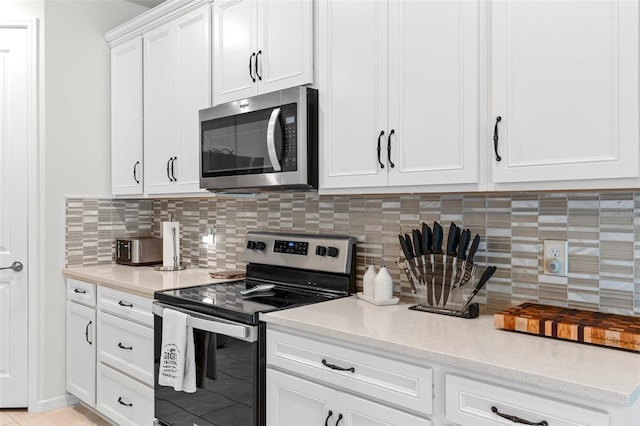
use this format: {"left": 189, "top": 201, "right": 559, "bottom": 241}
{"left": 111, "top": 37, "right": 143, "bottom": 195}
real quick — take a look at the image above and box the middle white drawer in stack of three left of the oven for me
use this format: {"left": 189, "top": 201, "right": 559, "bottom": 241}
{"left": 97, "top": 312, "right": 153, "bottom": 386}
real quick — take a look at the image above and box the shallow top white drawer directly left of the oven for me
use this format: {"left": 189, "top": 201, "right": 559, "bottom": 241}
{"left": 98, "top": 286, "right": 153, "bottom": 327}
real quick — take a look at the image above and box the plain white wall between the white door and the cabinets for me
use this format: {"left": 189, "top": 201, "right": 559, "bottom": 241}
{"left": 0, "top": 0, "right": 147, "bottom": 407}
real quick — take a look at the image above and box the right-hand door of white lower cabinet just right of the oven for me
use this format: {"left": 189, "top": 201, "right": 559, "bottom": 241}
{"left": 344, "top": 393, "right": 431, "bottom": 426}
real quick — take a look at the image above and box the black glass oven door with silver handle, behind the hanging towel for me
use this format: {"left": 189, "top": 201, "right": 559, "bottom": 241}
{"left": 153, "top": 301, "right": 265, "bottom": 426}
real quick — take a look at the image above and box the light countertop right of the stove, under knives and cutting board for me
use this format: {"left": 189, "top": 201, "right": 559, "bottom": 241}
{"left": 260, "top": 296, "right": 640, "bottom": 407}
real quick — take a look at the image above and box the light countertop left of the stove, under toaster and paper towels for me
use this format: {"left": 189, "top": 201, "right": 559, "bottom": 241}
{"left": 62, "top": 264, "right": 240, "bottom": 297}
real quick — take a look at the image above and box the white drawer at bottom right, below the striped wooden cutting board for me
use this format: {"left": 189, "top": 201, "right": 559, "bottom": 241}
{"left": 445, "top": 374, "right": 610, "bottom": 426}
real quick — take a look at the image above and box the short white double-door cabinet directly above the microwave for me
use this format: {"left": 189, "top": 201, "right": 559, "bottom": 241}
{"left": 213, "top": 0, "right": 313, "bottom": 104}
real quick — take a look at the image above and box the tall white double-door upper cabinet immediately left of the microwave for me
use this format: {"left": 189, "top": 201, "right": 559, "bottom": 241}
{"left": 144, "top": 5, "right": 211, "bottom": 194}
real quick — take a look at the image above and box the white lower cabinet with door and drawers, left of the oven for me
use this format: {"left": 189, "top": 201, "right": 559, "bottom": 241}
{"left": 67, "top": 278, "right": 154, "bottom": 426}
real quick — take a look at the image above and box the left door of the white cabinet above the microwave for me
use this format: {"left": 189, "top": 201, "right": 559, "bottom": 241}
{"left": 213, "top": 0, "right": 258, "bottom": 104}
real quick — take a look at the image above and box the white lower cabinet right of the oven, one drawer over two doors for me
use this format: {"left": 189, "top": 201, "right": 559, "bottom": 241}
{"left": 267, "top": 329, "right": 433, "bottom": 426}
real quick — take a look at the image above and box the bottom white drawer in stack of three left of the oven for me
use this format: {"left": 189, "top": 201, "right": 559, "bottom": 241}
{"left": 96, "top": 364, "right": 153, "bottom": 426}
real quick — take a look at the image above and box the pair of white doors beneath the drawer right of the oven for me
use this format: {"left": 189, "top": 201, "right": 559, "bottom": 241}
{"left": 267, "top": 369, "right": 431, "bottom": 426}
